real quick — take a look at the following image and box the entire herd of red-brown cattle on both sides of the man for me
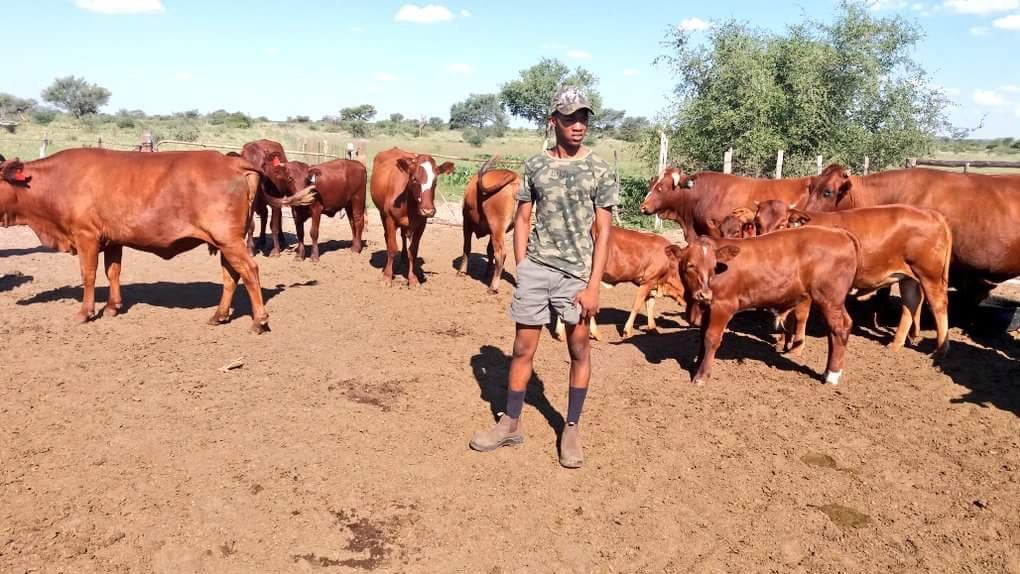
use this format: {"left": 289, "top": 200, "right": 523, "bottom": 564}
{"left": 0, "top": 140, "right": 1020, "bottom": 383}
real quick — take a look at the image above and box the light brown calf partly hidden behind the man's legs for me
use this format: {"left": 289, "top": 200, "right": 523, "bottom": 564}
{"left": 555, "top": 225, "right": 683, "bottom": 341}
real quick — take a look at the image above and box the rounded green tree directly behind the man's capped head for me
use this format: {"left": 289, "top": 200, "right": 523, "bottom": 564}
{"left": 500, "top": 58, "right": 602, "bottom": 127}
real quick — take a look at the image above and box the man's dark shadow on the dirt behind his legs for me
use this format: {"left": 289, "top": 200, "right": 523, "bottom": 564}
{"left": 471, "top": 345, "right": 566, "bottom": 443}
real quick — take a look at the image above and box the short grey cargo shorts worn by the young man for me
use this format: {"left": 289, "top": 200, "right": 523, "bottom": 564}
{"left": 510, "top": 258, "right": 588, "bottom": 325}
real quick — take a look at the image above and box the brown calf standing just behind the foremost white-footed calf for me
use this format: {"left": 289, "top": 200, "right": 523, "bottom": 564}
{"left": 755, "top": 201, "right": 953, "bottom": 355}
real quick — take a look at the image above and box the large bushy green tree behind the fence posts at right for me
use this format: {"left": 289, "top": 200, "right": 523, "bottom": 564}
{"left": 644, "top": 1, "right": 951, "bottom": 175}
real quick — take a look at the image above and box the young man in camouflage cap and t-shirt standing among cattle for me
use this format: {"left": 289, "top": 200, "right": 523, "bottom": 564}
{"left": 471, "top": 87, "right": 619, "bottom": 468}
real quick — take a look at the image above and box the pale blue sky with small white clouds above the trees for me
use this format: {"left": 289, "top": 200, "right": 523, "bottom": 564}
{"left": 0, "top": 0, "right": 1020, "bottom": 137}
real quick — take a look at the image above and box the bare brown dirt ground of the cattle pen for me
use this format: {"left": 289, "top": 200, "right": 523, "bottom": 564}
{"left": 0, "top": 212, "right": 1020, "bottom": 574}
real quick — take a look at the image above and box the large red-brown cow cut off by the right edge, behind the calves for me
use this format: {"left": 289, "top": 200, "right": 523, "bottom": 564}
{"left": 799, "top": 164, "right": 1020, "bottom": 303}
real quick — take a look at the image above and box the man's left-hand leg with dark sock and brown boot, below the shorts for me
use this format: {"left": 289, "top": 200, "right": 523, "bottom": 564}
{"left": 470, "top": 323, "right": 542, "bottom": 453}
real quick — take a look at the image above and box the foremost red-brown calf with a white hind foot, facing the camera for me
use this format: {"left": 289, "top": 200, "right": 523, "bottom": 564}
{"left": 667, "top": 226, "right": 860, "bottom": 384}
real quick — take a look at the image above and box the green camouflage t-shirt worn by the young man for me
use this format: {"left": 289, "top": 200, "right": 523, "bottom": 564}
{"left": 517, "top": 153, "right": 619, "bottom": 280}
